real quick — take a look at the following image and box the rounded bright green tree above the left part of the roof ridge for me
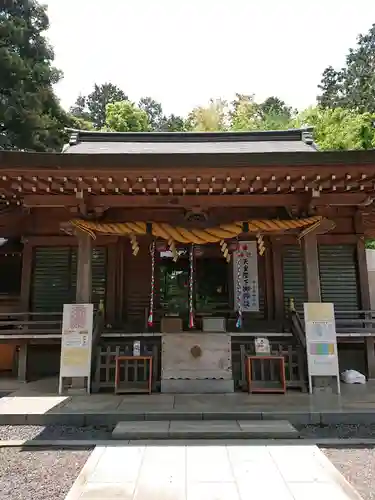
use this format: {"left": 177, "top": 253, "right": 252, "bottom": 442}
{"left": 106, "top": 101, "right": 150, "bottom": 132}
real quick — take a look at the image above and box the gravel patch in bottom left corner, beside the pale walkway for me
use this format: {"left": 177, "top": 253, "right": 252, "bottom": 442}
{"left": 0, "top": 448, "right": 91, "bottom": 500}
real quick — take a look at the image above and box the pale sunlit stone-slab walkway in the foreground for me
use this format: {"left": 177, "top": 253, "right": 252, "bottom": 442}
{"left": 66, "top": 441, "right": 361, "bottom": 500}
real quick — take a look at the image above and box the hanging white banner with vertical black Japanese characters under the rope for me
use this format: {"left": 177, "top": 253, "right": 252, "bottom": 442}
{"left": 233, "top": 241, "right": 259, "bottom": 312}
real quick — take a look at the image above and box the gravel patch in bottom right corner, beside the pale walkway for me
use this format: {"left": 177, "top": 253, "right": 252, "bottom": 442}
{"left": 322, "top": 448, "right": 375, "bottom": 500}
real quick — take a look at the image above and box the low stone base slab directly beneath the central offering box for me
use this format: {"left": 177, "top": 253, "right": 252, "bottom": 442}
{"left": 161, "top": 379, "right": 234, "bottom": 394}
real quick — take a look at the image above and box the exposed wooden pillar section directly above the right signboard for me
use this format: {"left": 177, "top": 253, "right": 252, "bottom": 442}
{"left": 302, "top": 233, "right": 322, "bottom": 302}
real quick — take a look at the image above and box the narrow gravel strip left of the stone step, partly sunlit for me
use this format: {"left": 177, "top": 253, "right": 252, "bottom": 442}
{"left": 0, "top": 425, "right": 113, "bottom": 441}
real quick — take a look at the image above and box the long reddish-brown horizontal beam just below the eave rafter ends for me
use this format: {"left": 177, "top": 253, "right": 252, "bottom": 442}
{"left": 22, "top": 193, "right": 367, "bottom": 209}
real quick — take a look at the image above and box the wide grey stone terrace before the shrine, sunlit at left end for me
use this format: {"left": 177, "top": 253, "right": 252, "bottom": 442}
{"left": 0, "top": 379, "right": 375, "bottom": 426}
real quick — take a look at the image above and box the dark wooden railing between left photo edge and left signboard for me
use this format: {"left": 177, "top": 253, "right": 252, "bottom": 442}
{"left": 0, "top": 312, "right": 62, "bottom": 338}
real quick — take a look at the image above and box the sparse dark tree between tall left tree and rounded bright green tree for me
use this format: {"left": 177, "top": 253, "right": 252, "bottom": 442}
{"left": 70, "top": 83, "right": 128, "bottom": 130}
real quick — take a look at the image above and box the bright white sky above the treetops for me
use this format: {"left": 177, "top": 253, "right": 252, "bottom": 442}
{"left": 43, "top": 0, "right": 375, "bottom": 115}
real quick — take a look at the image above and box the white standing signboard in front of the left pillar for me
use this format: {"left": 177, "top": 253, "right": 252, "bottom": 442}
{"left": 59, "top": 304, "right": 94, "bottom": 394}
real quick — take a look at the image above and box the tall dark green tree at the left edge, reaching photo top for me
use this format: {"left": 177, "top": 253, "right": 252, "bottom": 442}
{"left": 0, "top": 0, "right": 69, "bottom": 151}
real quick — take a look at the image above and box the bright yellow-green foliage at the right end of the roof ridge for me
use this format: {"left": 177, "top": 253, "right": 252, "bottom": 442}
{"left": 294, "top": 107, "right": 375, "bottom": 150}
